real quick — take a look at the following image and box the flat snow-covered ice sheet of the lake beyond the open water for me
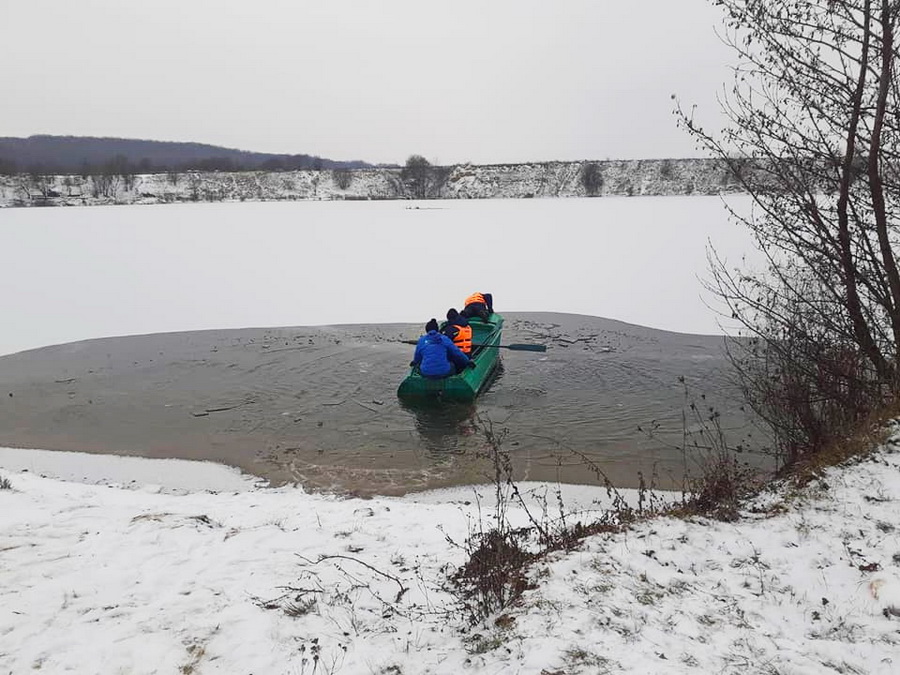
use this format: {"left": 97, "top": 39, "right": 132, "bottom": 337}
{"left": 0, "top": 197, "right": 751, "bottom": 354}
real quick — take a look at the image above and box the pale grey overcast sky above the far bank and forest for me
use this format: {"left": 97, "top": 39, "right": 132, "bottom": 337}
{"left": 0, "top": 0, "right": 730, "bottom": 164}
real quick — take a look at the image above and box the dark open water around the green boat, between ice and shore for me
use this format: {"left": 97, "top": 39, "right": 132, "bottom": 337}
{"left": 0, "top": 313, "right": 764, "bottom": 495}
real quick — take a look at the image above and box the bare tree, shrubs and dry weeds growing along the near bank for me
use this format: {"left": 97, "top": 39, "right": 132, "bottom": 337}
{"left": 453, "top": 0, "right": 900, "bottom": 621}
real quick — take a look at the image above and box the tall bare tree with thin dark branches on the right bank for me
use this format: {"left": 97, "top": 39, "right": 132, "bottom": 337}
{"left": 676, "top": 0, "right": 900, "bottom": 462}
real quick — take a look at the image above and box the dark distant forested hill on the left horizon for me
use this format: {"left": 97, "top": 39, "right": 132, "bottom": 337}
{"left": 0, "top": 136, "right": 372, "bottom": 175}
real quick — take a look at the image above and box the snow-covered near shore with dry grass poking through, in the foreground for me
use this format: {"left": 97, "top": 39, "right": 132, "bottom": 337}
{"left": 0, "top": 438, "right": 900, "bottom": 675}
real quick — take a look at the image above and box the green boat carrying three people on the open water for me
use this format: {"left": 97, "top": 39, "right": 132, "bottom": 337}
{"left": 397, "top": 312, "right": 503, "bottom": 401}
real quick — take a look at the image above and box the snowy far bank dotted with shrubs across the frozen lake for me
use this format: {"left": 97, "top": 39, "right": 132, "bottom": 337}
{"left": 0, "top": 159, "right": 739, "bottom": 207}
